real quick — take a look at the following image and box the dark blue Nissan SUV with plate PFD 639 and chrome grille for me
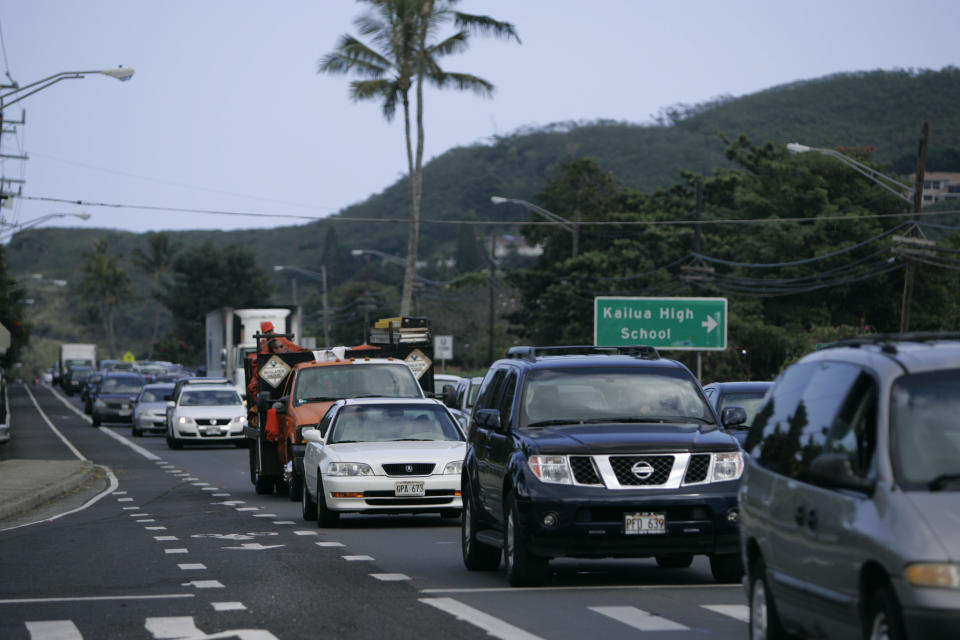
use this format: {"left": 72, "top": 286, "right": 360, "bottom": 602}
{"left": 461, "top": 346, "right": 743, "bottom": 586}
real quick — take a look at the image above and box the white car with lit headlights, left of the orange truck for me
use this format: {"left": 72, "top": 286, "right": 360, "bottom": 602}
{"left": 167, "top": 384, "right": 247, "bottom": 449}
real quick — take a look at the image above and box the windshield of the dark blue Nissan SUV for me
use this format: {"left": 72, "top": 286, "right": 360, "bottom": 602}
{"left": 521, "top": 367, "right": 713, "bottom": 426}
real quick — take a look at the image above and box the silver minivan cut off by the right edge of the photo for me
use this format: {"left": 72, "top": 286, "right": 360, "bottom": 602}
{"left": 739, "top": 334, "right": 960, "bottom": 639}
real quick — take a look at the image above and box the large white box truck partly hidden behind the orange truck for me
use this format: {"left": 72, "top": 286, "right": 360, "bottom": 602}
{"left": 206, "top": 307, "right": 303, "bottom": 394}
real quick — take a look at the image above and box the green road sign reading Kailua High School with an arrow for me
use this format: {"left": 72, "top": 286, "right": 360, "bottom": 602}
{"left": 593, "top": 296, "right": 727, "bottom": 351}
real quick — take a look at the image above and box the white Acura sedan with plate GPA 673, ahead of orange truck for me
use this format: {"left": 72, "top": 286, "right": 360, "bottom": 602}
{"left": 302, "top": 398, "right": 466, "bottom": 527}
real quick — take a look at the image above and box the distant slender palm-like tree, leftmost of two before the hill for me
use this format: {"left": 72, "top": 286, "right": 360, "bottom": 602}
{"left": 78, "top": 238, "right": 131, "bottom": 357}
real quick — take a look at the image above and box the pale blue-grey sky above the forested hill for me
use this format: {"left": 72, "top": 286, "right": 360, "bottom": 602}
{"left": 0, "top": 0, "right": 960, "bottom": 236}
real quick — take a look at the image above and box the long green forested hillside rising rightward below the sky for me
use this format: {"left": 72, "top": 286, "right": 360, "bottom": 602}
{"left": 6, "top": 67, "right": 960, "bottom": 368}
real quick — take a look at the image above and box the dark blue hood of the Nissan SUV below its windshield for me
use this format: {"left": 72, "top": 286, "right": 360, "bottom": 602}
{"left": 524, "top": 423, "right": 738, "bottom": 454}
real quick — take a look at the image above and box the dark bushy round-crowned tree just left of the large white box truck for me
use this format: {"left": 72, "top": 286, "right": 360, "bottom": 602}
{"left": 160, "top": 242, "right": 273, "bottom": 361}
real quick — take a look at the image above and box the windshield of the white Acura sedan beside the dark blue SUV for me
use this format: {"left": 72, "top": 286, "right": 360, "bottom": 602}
{"left": 327, "top": 404, "right": 463, "bottom": 444}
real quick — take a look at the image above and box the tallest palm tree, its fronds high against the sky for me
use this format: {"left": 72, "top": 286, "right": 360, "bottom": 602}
{"left": 318, "top": 0, "right": 520, "bottom": 316}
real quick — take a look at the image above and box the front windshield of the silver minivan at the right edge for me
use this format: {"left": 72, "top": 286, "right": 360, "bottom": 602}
{"left": 890, "top": 369, "right": 960, "bottom": 490}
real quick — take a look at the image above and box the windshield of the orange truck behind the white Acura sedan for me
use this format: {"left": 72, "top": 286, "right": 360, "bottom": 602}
{"left": 293, "top": 364, "right": 422, "bottom": 404}
